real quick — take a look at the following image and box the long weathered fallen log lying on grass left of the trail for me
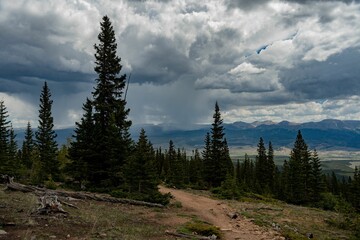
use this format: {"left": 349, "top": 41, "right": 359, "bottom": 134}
{"left": 6, "top": 182, "right": 164, "bottom": 208}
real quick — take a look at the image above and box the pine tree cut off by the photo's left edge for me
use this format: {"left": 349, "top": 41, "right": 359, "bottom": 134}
{"left": 0, "top": 101, "right": 10, "bottom": 174}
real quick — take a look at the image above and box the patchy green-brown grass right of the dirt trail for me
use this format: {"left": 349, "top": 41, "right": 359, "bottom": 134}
{"left": 229, "top": 198, "right": 356, "bottom": 240}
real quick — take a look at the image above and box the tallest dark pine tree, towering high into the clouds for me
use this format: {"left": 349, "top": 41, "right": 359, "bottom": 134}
{"left": 93, "top": 16, "right": 132, "bottom": 187}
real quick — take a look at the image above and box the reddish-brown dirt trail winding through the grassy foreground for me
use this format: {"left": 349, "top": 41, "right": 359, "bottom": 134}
{"left": 160, "top": 187, "right": 284, "bottom": 240}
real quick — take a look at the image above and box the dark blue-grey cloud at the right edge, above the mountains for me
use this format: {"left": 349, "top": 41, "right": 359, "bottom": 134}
{"left": 280, "top": 48, "right": 360, "bottom": 100}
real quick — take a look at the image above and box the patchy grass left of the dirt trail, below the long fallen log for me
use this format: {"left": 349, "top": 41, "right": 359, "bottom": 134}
{"left": 0, "top": 185, "right": 171, "bottom": 240}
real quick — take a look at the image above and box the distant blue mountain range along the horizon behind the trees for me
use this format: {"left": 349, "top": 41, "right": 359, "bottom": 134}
{"left": 16, "top": 119, "right": 360, "bottom": 150}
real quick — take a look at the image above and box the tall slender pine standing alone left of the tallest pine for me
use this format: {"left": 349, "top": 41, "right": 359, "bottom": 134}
{"left": 35, "top": 82, "right": 59, "bottom": 181}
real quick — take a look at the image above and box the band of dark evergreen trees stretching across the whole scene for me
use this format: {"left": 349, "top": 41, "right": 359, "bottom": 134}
{"left": 0, "top": 16, "right": 360, "bottom": 211}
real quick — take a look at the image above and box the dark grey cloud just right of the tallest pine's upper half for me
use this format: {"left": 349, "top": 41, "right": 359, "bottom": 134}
{"left": 120, "top": 26, "right": 193, "bottom": 84}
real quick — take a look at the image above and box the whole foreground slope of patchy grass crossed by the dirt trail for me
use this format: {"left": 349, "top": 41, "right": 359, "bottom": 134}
{"left": 0, "top": 185, "right": 359, "bottom": 240}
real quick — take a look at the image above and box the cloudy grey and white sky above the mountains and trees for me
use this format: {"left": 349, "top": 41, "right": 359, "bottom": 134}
{"left": 0, "top": 0, "right": 360, "bottom": 128}
